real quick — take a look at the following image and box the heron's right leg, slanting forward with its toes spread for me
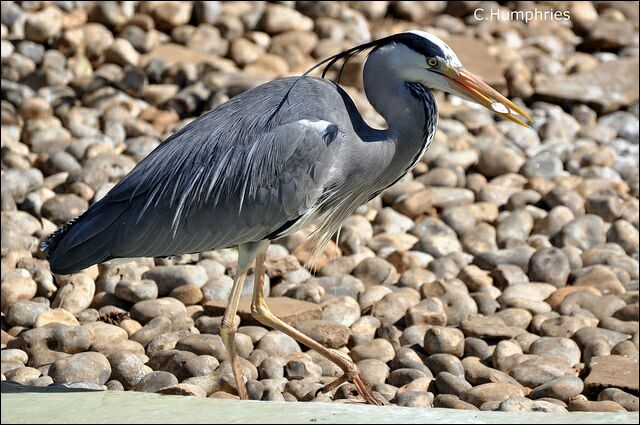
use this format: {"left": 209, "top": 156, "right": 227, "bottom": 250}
{"left": 251, "top": 253, "right": 379, "bottom": 405}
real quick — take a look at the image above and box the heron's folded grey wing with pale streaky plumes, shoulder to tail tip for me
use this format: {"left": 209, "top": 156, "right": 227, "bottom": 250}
{"left": 44, "top": 120, "right": 341, "bottom": 273}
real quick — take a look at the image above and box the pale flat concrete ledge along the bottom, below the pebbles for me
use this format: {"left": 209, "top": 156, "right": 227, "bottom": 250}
{"left": 1, "top": 383, "right": 638, "bottom": 425}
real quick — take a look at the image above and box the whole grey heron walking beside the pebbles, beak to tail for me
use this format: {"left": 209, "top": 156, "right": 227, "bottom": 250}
{"left": 41, "top": 31, "right": 530, "bottom": 404}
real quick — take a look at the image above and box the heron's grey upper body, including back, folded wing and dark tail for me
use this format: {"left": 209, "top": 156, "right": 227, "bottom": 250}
{"left": 42, "top": 78, "right": 362, "bottom": 273}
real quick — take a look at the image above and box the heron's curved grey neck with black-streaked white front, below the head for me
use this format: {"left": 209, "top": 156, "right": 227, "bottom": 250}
{"left": 364, "top": 57, "right": 438, "bottom": 174}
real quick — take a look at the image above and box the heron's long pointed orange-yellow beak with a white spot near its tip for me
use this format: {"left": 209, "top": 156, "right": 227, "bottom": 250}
{"left": 443, "top": 67, "right": 533, "bottom": 128}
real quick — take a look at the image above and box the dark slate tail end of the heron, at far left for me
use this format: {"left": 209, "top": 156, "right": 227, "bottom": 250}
{"left": 40, "top": 202, "right": 126, "bottom": 274}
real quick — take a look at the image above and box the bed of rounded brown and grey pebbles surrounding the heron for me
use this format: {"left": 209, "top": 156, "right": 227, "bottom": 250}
{"left": 1, "top": 1, "right": 639, "bottom": 412}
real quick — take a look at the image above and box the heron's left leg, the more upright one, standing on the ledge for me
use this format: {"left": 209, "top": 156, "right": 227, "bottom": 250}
{"left": 220, "top": 242, "right": 268, "bottom": 400}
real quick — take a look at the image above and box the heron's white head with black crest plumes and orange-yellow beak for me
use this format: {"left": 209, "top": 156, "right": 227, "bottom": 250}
{"left": 310, "top": 31, "right": 531, "bottom": 127}
